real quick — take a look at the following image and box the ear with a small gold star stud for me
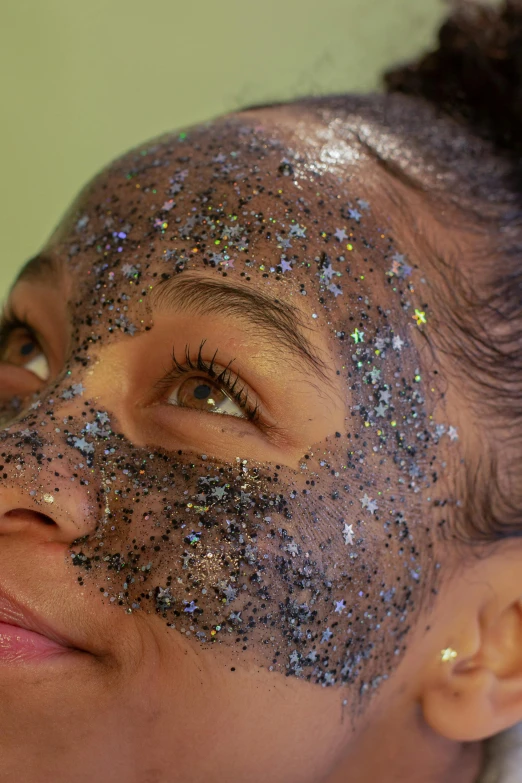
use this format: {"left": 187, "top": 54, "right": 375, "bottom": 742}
{"left": 421, "top": 588, "right": 522, "bottom": 742}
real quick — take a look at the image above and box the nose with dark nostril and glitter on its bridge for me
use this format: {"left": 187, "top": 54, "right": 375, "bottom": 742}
{"left": 0, "top": 392, "right": 110, "bottom": 543}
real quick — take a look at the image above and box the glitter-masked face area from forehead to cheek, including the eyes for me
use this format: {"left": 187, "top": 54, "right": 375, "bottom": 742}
{"left": 0, "top": 108, "right": 457, "bottom": 693}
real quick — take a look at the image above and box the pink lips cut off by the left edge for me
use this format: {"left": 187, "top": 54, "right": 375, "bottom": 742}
{"left": 0, "top": 588, "right": 79, "bottom": 661}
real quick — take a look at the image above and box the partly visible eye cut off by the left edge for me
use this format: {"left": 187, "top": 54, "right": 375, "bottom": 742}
{"left": 0, "top": 317, "right": 51, "bottom": 381}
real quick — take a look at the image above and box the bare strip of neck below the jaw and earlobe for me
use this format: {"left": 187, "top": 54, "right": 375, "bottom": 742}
{"left": 322, "top": 705, "right": 484, "bottom": 783}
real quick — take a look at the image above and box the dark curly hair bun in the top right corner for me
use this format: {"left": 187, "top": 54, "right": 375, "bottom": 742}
{"left": 383, "top": 0, "right": 522, "bottom": 158}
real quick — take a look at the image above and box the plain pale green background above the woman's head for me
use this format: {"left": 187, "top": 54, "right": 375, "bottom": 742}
{"left": 0, "top": 0, "right": 496, "bottom": 298}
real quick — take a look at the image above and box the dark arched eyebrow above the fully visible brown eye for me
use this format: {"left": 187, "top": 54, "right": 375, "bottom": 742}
{"left": 151, "top": 276, "right": 330, "bottom": 382}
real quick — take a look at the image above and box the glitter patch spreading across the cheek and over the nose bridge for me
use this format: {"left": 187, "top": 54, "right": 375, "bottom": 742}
{"left": 2, "top": 352, "right": 438, "bottom": 687}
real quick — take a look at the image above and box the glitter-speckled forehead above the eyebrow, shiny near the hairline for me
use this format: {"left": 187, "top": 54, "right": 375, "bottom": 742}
{"left": 27, "top": 107, "right": 402, "bottom": 356}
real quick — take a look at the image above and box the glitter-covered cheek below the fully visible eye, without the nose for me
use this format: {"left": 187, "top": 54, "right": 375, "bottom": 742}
{"left": 59, "top": 426, "right": 426, "bottom": 685}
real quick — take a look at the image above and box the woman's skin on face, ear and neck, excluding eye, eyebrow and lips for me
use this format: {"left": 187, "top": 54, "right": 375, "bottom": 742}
{"left": 0, "top": 106, "right": 522, "bottom": 783}
